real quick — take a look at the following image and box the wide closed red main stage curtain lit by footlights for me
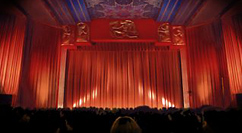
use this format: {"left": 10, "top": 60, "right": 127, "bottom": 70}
{"left": 64, "top": 43, "right": 183, "bottom": 108}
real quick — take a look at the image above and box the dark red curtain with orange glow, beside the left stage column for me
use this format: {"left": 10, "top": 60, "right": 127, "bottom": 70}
{"left": 18, "top": 21, "right": 61, "bottom": 108}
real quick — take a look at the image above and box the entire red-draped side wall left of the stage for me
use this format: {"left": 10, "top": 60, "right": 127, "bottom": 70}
{"left": 0, "top": 9, "right": 61, "bottom": 108}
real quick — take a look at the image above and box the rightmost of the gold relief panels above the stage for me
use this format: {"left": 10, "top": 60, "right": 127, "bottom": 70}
{"left": 172, "top": 26, "right": 185, "bottom": 45}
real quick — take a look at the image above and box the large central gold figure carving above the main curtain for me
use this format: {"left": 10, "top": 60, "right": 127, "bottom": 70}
{"left": 110, "top": 20, "right": 138, "bottom": 38}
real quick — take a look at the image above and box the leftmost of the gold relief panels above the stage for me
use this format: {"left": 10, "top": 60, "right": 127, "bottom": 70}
{"left": 62, "top": 25, "right": 74, "bottom": 45}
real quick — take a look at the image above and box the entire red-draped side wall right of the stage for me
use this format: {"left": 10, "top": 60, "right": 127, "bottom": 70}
{"left": 186, "top": 14, "right": 242, "bottom": 107}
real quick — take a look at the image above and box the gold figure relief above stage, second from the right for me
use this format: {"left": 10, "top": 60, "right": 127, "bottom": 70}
{"left": 158, "top": 23, "right": 171, "bottom": 42}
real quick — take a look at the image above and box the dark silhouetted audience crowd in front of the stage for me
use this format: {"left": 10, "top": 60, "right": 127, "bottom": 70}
{"left": 0, "top": 105, "right": 242, "bottom": 133}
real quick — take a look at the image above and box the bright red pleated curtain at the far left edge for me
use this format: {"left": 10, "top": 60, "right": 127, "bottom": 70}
{"left": 0, "top": 14, "right": 26, "bottom": 104}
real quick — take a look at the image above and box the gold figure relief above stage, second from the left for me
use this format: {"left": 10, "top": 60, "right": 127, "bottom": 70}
{"left": 76, "top": 22, "right": 89, "bottom": 42}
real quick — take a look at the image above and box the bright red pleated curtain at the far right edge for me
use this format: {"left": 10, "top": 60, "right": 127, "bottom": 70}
{"left": 222, "top": 14, "right": 242, "bottom": 104}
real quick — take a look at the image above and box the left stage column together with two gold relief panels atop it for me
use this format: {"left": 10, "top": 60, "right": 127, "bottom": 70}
{"left": 57, "top": 22, "right": 90, "bottom": 108}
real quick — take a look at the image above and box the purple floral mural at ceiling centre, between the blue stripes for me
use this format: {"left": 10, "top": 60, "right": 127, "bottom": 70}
{"left": 85, "top": 0, "right": 163, "bottom": 19}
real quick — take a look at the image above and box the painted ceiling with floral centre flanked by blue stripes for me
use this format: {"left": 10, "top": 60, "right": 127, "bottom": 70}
{"left": 42, "top": 0, "right": 206, "bottom": 25}
